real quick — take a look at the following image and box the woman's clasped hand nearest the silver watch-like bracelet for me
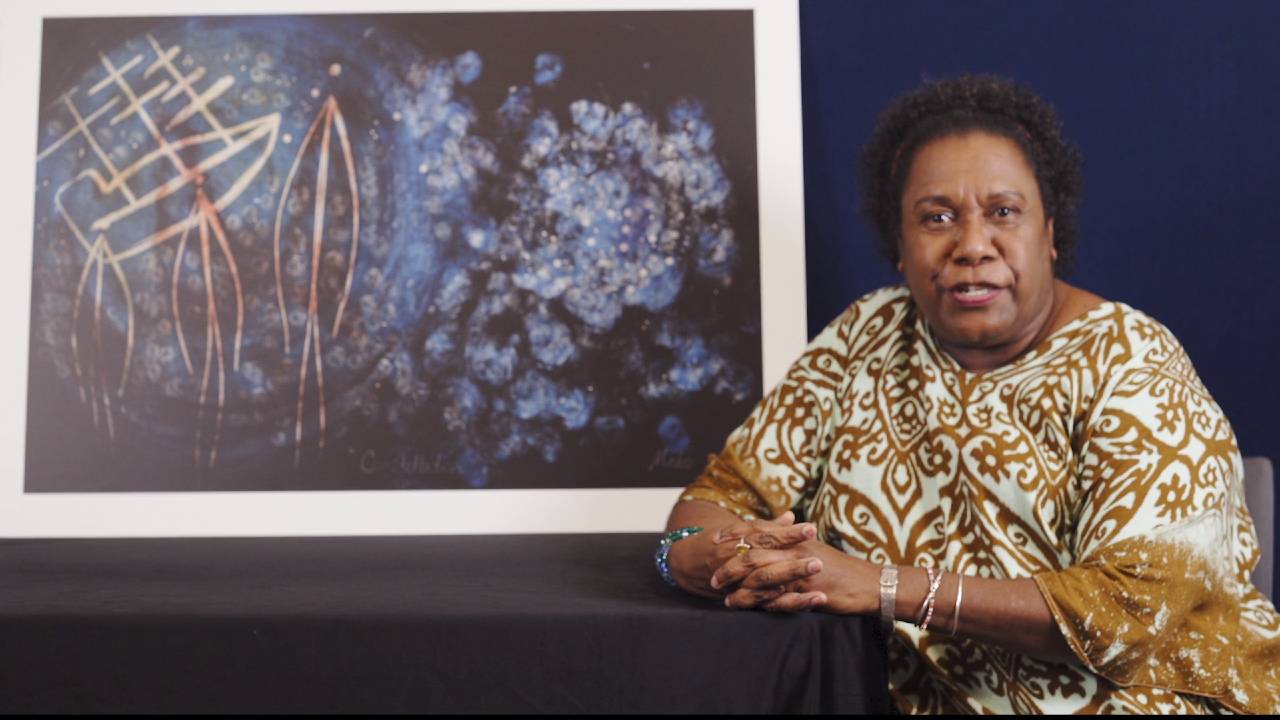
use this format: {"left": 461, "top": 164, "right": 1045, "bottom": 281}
{"left": 712, "top": 541, "right": 879, "bottom": 615}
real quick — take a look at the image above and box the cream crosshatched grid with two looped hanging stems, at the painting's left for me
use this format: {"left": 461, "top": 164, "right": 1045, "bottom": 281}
{"left": 37, "top": 36, "right": 279, "bottom": 465}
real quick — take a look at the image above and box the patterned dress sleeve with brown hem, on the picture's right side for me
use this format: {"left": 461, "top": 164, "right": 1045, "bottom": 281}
{"left": 1036, "top": 314, "right": 1280, "bottom": 712}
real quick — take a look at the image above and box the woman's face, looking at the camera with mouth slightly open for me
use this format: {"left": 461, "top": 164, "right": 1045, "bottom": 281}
{"left": 899, "top": 131, "right": 1057, "bottom": 366}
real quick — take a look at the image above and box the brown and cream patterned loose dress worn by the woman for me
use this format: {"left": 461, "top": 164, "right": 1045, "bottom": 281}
{"left": 682, "top": 286, "right": 1280, "bottom": 712}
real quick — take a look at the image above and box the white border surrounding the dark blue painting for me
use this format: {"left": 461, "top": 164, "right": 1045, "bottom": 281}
{"left": 0, "top": 0, "right": 806, "bottom": 538}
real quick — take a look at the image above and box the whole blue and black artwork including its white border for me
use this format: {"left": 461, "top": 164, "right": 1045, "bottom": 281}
{"left": 0, "top": 1, "right": 805, "bottom": 537}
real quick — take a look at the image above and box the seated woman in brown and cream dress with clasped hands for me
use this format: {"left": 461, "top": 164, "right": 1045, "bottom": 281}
{"left": 659, "top": 77, "right": 1280, "bottom": 712}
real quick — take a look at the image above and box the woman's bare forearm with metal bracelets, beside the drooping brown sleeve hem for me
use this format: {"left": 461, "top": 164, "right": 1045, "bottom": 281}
{"left": 895, "top": 565, "right": 1075, "bottom": 662}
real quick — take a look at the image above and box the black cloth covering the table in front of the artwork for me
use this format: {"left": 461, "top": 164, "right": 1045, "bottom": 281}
{"left": 0, "top": 534, "right": 888, "bottom": 712}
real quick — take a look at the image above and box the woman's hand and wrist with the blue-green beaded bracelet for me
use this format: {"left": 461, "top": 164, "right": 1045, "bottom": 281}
{"left": 667, "top": 511, "right": 818, "bottom": 597}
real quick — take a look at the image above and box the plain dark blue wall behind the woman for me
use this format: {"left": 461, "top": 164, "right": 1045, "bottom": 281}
{"left": 800, "top": 0, "right": 1280, "bottom": 561}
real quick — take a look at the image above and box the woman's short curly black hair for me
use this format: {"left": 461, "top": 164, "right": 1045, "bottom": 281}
{"left": 860, "top": 74, "right": 1083, "bottom": 277}
